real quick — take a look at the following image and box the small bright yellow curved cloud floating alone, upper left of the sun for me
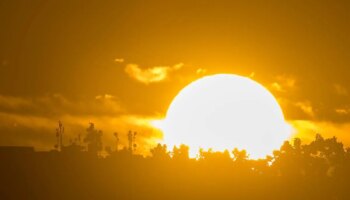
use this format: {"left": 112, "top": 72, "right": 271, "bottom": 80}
{"left": 125, "top": 63, "right": 183, "bottom": 84}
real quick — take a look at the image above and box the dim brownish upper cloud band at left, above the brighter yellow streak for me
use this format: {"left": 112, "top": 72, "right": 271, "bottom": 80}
{"left": 0, "top": 94, "right": 125, "bottom": 117}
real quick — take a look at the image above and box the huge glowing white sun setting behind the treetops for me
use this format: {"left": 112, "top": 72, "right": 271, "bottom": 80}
{"left": 157, "top": 74, "right": 291, "bottom": 158}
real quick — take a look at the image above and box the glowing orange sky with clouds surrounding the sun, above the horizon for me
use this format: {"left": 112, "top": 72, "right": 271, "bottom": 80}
{"left": 0, "top": 0, "right": 350, "bottom": 152}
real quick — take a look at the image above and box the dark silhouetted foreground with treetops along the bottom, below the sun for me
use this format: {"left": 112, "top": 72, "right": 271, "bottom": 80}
{"left": 0, "top": 135, "right": 350, "bottom": 200}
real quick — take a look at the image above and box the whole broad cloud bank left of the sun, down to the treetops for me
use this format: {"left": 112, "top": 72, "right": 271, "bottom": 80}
{"left": 0, "top": 94, "right": 162, "bottom": 154}
